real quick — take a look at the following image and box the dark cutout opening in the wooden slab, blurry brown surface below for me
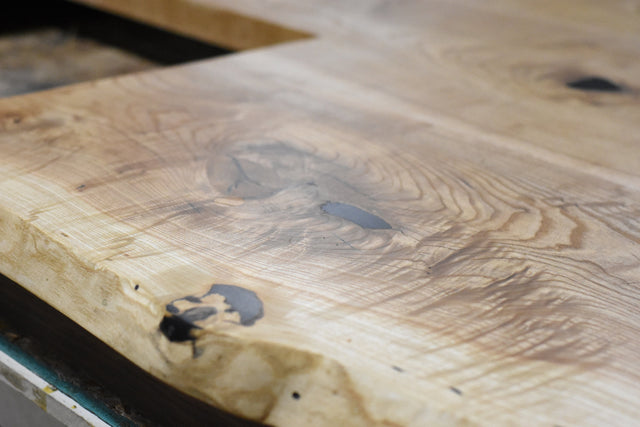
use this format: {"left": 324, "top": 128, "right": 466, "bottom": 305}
{"left": 0, "top": 0, "right": 231, "bottom": 97}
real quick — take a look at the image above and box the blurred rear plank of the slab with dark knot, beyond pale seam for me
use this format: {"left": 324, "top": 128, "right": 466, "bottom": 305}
{"left": 72, "top": 0, "right": 640, "bottom": 176}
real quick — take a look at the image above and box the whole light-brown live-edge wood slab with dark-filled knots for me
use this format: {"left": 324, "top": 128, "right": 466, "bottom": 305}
{"left": 0, "top": 0, "right": 640, "bottom": 426}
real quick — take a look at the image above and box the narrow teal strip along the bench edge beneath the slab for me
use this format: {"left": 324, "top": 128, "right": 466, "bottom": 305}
{"left": 0, "top": 335, "right": 137, "bottom": 427}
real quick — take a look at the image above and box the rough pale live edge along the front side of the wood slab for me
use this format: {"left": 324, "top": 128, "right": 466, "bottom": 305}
{"left": 0, "top": 202, "right": 470, "bottom": 426}
